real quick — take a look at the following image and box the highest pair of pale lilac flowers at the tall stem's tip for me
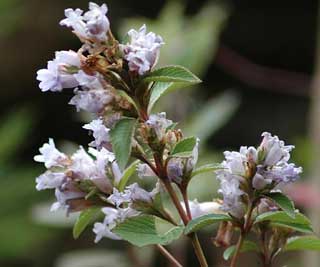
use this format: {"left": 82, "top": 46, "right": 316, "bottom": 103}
{"left": 60, "top": 2, "right": 110, "bottom": 41}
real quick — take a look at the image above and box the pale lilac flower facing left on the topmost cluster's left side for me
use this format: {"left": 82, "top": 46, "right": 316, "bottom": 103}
{"left": 37, "top": 50, "right": 80, "bottom": 92}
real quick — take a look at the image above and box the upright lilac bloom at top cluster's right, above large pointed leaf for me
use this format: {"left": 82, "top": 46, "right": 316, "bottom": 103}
{"left": 122, "top": 25, "right": 164, "bottom": 75}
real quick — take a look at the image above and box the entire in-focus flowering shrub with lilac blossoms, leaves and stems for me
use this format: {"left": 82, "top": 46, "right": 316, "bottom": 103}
{"left": 34, "top": 2, "right": 320, "bottom": 267}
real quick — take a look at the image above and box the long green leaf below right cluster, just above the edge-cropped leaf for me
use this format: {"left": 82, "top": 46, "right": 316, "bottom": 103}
{"left": 254, "top": 211, "right": 313, "bottom": 233}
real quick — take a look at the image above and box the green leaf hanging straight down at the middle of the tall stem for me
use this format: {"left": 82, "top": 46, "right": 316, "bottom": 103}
{"left": 110, "top": 118, "right": 136, "bottom": 170}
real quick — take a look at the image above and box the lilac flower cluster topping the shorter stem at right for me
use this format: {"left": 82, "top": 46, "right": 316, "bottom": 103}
{"left": 216, "top": 132, "right": 302, "bottom": 218}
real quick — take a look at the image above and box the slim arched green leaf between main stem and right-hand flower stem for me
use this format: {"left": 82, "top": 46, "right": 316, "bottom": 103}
{"left": 184, "top": 214, "right": 232, "bottom": 235}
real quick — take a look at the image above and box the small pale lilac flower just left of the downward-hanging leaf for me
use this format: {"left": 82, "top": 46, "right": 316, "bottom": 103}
{"left": 82, "top": 118, "right": 110, "bottom": 148}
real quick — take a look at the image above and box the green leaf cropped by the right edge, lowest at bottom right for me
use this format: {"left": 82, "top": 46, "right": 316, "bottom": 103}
{"left": 284, "top": 236, "right": 320, "bottom": 251}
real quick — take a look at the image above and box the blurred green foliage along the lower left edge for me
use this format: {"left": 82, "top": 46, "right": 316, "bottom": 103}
{"left": 0, "top": 108, "right": 54, "bottom": 259}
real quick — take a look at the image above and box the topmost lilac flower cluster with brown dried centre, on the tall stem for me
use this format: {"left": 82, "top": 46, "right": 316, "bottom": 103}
{"left": 37, "top": 2, "right": 163, "bottom": 116}
